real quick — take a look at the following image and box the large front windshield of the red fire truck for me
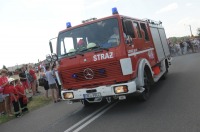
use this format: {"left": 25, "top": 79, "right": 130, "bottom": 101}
{"left": 58, "top": 18, "right": 120, "bottom": 56}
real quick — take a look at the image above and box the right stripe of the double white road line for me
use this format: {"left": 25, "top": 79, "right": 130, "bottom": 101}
{"left": 73, "top": 102, "right": 118, "bottom": 132}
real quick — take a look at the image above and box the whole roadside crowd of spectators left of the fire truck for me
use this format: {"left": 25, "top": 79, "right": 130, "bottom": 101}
{"left": 0, "top": 61, "right": 61, "bottom": 117}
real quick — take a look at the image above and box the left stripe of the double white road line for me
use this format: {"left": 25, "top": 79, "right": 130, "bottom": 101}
{"left": 64, "top": 104, "right": 109, "bottom": 132}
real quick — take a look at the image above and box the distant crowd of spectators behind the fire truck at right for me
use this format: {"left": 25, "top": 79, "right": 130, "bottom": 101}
{"left": 169, "top": 38, "right": 200, "bottom": 56}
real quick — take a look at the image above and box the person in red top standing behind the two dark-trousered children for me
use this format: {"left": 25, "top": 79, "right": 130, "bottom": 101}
{"left": 28, "top": 65, "right": 37, "bottom": 95}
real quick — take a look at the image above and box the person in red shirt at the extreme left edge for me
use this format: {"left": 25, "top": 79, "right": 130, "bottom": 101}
{"left": 0, "top": 69, "right": 13, "bottom": 116}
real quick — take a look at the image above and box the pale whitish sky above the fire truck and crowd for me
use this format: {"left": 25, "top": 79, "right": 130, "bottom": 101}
{"left": 0, "top": 0, "right": 200, "bottom": 69}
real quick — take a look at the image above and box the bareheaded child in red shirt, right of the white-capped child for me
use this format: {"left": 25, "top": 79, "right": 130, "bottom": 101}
{"left": 15, "top": 79, "right": 28, "bottom": 113}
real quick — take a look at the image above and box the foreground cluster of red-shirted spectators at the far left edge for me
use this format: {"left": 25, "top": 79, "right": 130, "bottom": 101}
{"left": 0, "top": 69, "right": 28, "bottom": 117}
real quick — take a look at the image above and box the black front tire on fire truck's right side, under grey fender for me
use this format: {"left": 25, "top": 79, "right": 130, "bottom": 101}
{"left": 139, "top": 70, "right": 151, "bottom": 101}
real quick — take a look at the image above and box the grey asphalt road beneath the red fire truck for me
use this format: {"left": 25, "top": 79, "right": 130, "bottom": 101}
{"left": 0, "top": 53, "right": 200, "bottom": 132}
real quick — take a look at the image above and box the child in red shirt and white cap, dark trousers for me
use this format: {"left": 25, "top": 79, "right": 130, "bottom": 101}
{"left": 9, "top": 78, "right": 21, "bottom": 118}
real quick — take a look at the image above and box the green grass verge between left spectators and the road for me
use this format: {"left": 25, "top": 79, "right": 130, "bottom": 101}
{"left": 0, "top": 96, "right": 52, "bottom": 124}
